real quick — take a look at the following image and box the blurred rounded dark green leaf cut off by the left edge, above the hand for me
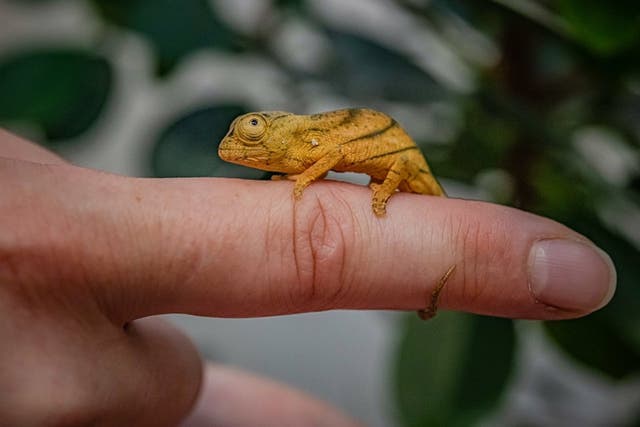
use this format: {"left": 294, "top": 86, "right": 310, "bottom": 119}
{"left": 0, "top": 49, "right": 113, "bottom": 141}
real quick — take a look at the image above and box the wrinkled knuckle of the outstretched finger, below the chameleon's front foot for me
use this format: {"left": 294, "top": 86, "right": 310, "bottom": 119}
{"left": 291, "top": 189, "right": 354, "bottom": 310}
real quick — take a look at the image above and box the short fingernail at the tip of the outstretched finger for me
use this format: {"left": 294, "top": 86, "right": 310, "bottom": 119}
{"left": 529, "top": 239, "right": 616, "bottom": 311}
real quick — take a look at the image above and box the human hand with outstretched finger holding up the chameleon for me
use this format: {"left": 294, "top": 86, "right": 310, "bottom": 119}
{"left": 0, "top": 133, "right": 615, "bottom": 426}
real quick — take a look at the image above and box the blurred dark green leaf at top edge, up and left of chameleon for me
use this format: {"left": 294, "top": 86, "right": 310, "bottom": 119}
{"left": 90, "top": 0, "right": 239, "bottom": 74}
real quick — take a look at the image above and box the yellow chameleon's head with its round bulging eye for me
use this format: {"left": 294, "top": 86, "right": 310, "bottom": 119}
{"left": 218, "top": 111, "right": 291, "bottom": 172}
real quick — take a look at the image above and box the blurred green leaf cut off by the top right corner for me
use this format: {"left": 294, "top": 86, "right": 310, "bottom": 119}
{"left": 557, "top": 0, "right": 640, "bottom": 55}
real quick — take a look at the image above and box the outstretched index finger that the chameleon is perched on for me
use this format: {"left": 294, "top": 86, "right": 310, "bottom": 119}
{"left": 5, "top": 164, "right": 615, "bottom": 321}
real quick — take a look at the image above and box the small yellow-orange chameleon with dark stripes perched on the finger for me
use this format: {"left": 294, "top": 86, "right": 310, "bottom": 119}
{"left": 218, "top": 108, "right": 445, "bottom": 216}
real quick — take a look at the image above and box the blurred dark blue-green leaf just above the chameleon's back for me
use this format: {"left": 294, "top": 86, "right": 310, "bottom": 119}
{"left": 324, "top": 31, "right": 448, "bottom": 102}
